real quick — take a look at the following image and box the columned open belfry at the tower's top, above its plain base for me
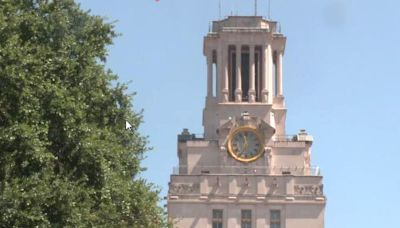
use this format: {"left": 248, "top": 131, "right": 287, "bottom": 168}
{"left": 204, "top": 16, "right": 286, "bottom": 104}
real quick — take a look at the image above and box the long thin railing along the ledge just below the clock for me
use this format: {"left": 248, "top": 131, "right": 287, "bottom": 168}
{"left": 173, "top": 166, "right": 321, "bottom": 176}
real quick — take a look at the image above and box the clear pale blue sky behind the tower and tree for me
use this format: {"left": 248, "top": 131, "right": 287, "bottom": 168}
{"left": 79, "top": 0, "right": 400, "bottom": 228}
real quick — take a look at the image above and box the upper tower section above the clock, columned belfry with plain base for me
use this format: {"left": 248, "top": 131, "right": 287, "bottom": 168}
{"left": 203, "top": 16, "right": 286, "bottom": 139}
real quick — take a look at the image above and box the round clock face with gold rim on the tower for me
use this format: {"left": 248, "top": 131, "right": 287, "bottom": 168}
{"left": 228, "top": 126, "right": 264, "bottom": 162}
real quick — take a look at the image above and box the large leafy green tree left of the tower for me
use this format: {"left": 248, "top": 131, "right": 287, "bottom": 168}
{"left": 0, "top": 0, "right": 165, "bottom": 227}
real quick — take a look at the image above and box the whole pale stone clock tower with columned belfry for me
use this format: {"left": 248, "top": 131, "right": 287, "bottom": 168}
{"left": 167, "top": 16, "right": 326, "bottom": 228}
